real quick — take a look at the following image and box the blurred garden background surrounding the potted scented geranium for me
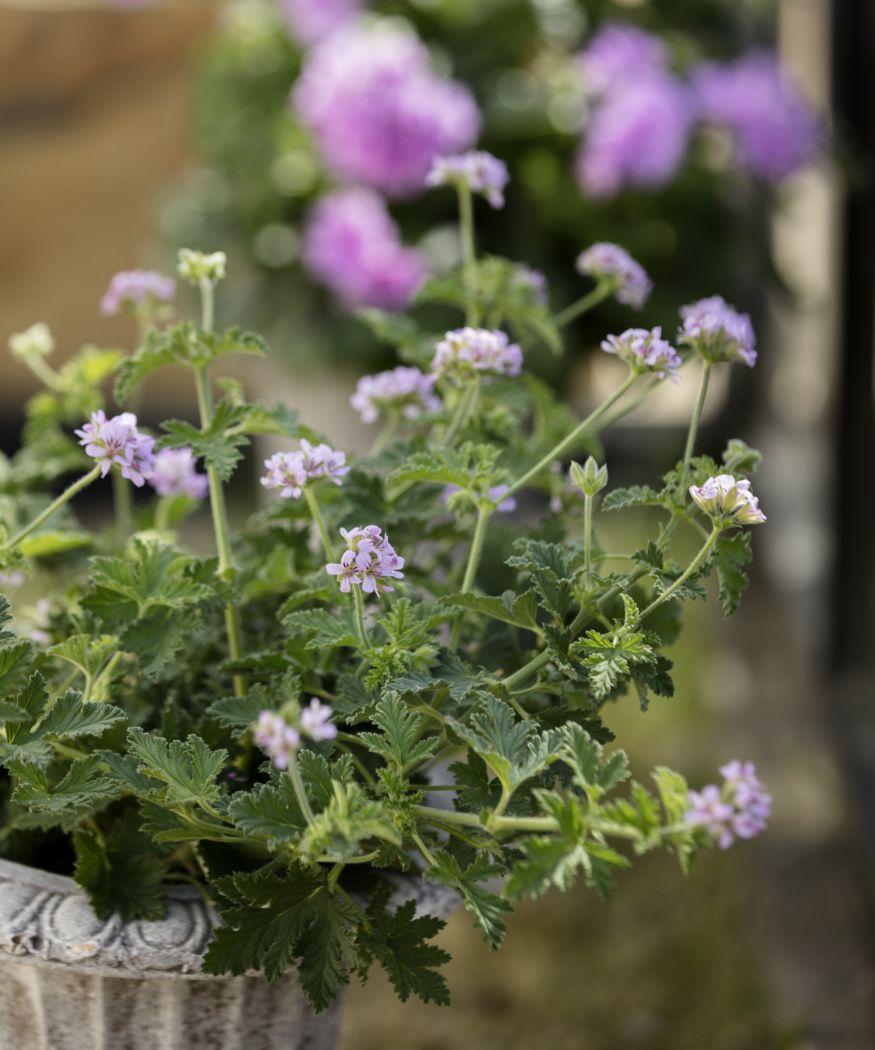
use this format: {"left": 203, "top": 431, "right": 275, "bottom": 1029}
{"left": 0, "top": 0, "right": 875, "bottom": 1050}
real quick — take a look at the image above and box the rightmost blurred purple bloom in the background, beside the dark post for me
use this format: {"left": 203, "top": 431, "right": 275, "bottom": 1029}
{"left": 693, "top": 50, "right": 821, "bottom": 182}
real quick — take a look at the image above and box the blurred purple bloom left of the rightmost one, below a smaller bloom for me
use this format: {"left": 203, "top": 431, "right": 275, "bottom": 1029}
{"left": 577, "top": 72, "right": 694, "bottom": 197}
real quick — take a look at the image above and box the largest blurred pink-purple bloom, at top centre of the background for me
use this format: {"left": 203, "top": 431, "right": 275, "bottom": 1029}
{"left": 293, "top": 21, "right": 480, "bottom": 197}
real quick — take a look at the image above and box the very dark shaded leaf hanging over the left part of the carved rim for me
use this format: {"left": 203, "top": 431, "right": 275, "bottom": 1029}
{"left": 74, "top": 821, "right": 167, "bottom": 922}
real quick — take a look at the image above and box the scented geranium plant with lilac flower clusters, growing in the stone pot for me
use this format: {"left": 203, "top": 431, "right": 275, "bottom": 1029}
{"left": 0, "top": 155, "right": 770, "bottom": 1008}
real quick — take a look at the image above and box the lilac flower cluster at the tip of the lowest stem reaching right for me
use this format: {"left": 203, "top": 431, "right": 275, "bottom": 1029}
{"left": 684, "top": 759, "right": 772, "bottom": 849}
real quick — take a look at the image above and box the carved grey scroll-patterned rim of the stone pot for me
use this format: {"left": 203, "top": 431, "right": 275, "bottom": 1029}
{"left": 0, "top": 859, "right": 459, "bottom": 981}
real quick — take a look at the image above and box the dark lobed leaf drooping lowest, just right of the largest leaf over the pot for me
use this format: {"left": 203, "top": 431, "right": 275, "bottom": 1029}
{"left": 361, "top": 901, "right": 450, "bottom": 1006}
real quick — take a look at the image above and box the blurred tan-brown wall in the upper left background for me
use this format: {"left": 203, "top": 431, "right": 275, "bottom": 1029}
{"left": 0, "top": 0, "right": 211, "bottom": 422}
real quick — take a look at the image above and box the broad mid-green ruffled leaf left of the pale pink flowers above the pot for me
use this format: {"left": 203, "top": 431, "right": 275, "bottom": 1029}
{"left": 127, "top": 726, "right": 228, "bottom": 805}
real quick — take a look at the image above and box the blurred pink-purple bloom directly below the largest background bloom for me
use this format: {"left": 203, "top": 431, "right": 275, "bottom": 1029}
{"left": 303, "top": 187, "right": 425, "bottom": 310}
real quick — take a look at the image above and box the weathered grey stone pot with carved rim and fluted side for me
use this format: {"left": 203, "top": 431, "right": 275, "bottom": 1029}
{"left": 0, "top": 860, "right": 456, "bottom": 1050}
